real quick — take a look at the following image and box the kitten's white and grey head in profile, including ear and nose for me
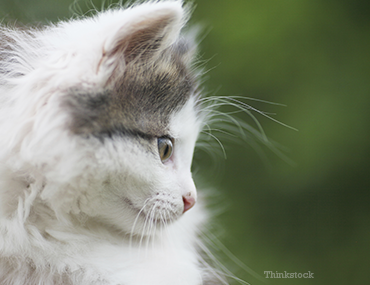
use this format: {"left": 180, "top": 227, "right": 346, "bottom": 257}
{"left": 1, "top": 1, "right": 201, "bottom": 234}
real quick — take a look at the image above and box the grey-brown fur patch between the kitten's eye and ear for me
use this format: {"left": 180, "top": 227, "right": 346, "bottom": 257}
{"left": 64, "top": 40, "right": 197, "bottom": 137}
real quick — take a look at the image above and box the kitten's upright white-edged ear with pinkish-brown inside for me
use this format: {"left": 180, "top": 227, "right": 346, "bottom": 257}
{"left": 98, "top": 1, "right": 185, "bottom": 79}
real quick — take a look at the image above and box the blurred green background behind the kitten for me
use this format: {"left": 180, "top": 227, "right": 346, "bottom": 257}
{"left": 0, "top": 0, "right": 370, "bottom": 285}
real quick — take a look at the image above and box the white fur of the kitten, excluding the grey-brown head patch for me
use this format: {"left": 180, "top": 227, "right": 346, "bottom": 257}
{"left": 0, "top": 1, "right": 220, "bottom": 285}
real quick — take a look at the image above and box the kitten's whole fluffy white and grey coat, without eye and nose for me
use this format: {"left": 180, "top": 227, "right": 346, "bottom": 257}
{"left": 0, "top": 1, "right": 230, "bottom": 285}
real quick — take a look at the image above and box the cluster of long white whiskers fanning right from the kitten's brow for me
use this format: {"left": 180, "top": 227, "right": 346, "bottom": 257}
{"left": 196, "top": 96, "right": 296, "bottom": 166}
